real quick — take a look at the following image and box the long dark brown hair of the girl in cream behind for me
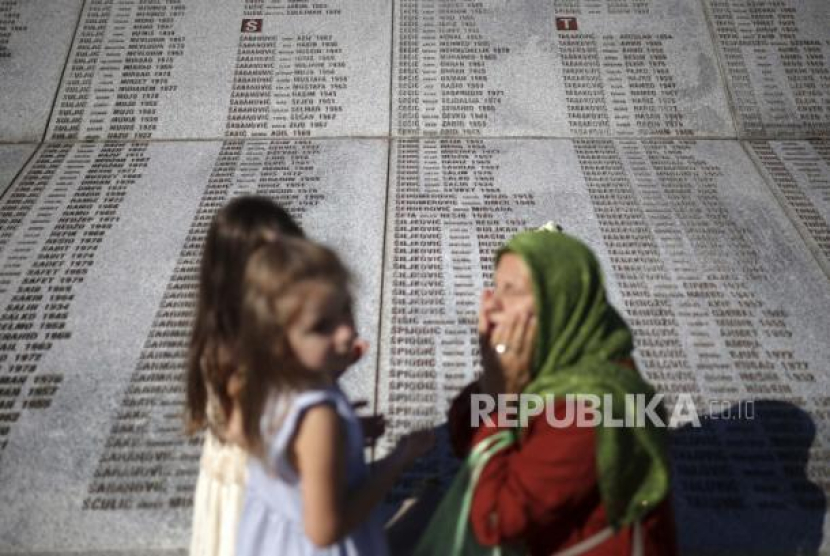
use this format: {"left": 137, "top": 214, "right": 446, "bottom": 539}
{"left": 185, "top": 196, "right": 303, "bottom": 434}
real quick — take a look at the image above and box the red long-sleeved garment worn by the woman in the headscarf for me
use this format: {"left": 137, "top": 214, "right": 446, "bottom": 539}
{"left": 449, "top": 383, "right": 677, "bottom": 556}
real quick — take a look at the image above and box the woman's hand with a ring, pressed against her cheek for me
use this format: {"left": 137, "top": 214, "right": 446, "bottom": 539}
{"left": 478, "top": 290, "right": 536, "bottom": 395}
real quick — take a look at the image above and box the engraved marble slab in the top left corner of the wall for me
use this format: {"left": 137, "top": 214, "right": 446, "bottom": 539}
{"left": 0, "top": 0, "right": 83, "bottom": 142}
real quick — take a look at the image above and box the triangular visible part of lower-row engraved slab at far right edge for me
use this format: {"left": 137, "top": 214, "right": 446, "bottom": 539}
{"left": 746, "top": 141, "right": 830, "bottom": 276}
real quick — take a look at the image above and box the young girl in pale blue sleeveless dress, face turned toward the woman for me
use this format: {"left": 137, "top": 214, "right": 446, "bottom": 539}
{"left": 237, "top": 238, "right": 433, "bottom": 556}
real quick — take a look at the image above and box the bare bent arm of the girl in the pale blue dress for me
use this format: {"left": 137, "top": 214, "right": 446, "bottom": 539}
{"left": 294, "top": 405, "right": 432, "bottom": 547}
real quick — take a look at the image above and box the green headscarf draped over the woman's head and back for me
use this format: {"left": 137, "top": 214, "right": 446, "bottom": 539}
{"left": 500, "top": 230, "right": 669, "bottom": 528}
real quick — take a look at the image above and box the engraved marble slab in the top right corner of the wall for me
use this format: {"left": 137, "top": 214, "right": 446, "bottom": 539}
{"left": 705, "top": 0, "right": 830, "bottom": 138}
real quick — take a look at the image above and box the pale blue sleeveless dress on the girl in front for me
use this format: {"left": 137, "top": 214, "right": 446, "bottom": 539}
{"left": 237, "top": 387, "right": 387, "bottom": 556}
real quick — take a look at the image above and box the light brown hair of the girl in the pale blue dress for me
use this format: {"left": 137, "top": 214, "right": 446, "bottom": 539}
{"left": 239, "top": 238, "right": 349, "bottom": 455}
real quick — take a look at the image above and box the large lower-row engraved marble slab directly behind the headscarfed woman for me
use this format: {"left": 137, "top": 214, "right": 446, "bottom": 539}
{"left": 378, "top": 139, "right": 830, "bottom": 554}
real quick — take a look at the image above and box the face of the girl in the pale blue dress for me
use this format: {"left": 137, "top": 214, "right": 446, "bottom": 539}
{"left": 287, "top": 280, "right": 357, "bottom": 378}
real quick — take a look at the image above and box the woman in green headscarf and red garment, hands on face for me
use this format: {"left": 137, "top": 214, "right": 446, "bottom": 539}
{"left": 416, "top": 230, "right": 676, "bottom": 556}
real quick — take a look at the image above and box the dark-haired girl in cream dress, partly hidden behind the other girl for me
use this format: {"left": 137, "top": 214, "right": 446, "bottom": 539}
{"left": 186, "top": 196, "right": 302, "bottom": 556}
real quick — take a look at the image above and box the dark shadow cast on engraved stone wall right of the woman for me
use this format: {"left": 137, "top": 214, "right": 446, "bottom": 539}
{"left": 671, "top": 400, "right": 827, "bottom": 556}
